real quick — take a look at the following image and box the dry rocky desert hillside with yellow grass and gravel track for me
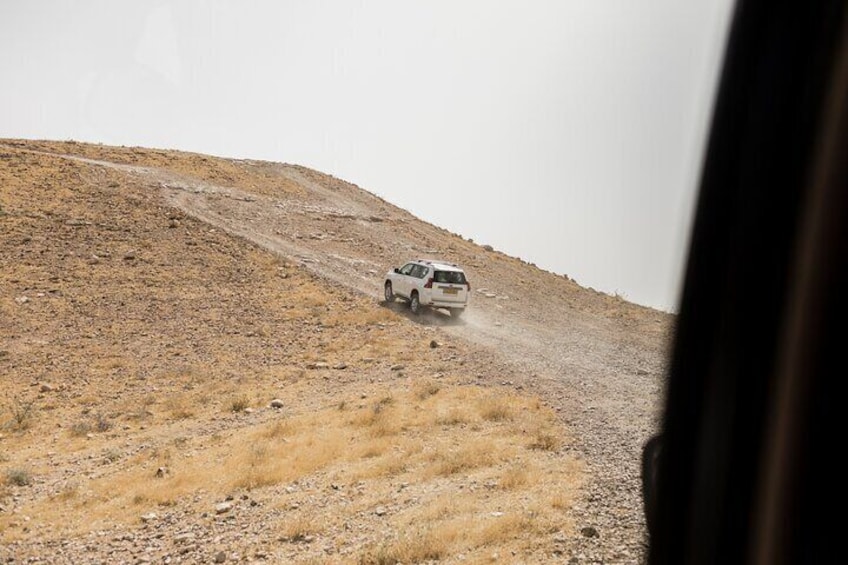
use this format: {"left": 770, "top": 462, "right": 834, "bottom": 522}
{"left": 0, "top": 140, "right": 671, "bottom": 563}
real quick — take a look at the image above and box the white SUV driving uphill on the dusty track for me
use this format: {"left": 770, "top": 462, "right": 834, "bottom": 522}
{"left": 384, "top": 259, "right": 471, "bottom": 318}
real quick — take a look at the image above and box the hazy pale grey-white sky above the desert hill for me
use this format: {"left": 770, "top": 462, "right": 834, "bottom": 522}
{"left": 0, "top": 0, "right": 732, "bottom": 309}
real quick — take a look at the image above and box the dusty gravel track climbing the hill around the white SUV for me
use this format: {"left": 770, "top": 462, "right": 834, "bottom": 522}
{"left": 14, "top": 148, "right": 668, "bottom": 563}
